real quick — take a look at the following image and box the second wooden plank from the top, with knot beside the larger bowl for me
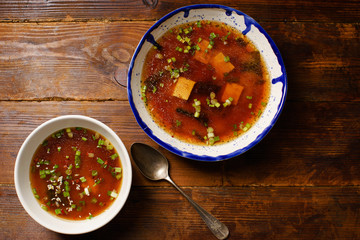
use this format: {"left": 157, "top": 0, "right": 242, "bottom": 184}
{"left": 0, "top": 22, "right": 360, "bottom": 101}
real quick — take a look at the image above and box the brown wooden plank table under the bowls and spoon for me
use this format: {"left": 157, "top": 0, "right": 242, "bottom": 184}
{"left": 0, "top": 0, "right": 360, "bottom": 239}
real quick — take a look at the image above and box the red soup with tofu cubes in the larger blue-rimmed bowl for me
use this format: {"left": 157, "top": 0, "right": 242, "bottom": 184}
{"left": 141, "top": 21, "right": 270, "bottom": 145}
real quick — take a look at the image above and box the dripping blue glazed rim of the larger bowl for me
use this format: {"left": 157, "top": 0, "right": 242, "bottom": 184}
{"left": 127, "top": 4, "right": 288, "bottom": 162}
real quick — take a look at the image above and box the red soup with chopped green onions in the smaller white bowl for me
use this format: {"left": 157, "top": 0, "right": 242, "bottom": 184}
{"left": 30, "top": 128, "right": 122, "bottom": 220}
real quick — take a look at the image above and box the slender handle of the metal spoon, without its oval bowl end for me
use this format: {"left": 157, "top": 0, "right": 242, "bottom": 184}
{"left": 165, "top": 176, "right": 229, "bottom": 239}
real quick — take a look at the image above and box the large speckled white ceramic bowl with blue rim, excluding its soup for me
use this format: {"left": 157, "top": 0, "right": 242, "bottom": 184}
{"left": 128, "top": 4, "right": 287, "bottom": 161}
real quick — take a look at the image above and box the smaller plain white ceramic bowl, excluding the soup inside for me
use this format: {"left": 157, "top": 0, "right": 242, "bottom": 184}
{"left": 14, "top": 115, "right": 132, "bottom": 234}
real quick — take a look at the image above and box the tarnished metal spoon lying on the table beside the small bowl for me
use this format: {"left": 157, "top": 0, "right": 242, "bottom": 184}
{"left": 131, "top": 143, "right": 229, "bottom": 239}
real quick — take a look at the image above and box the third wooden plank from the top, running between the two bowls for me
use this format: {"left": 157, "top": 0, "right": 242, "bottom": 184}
{"left": 0, "top": 101, "right": 360, "bottom": 186}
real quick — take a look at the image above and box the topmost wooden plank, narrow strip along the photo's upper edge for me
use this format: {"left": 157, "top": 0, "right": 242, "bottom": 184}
{"left": 0, "top": 0, "right": 360, "bottom": 22}
